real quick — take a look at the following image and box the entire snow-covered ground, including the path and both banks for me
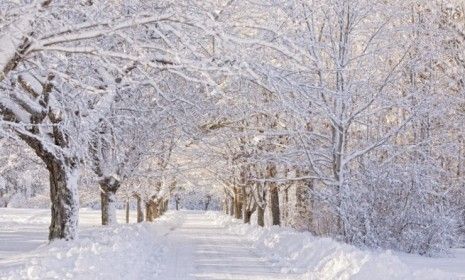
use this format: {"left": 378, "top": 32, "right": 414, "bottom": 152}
{"left": 0, "top": 208, "right": 465, "bottom": 280}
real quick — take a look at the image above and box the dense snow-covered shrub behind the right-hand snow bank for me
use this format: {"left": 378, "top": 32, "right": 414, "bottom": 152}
{"left": 341, "top": 162, "right": 460, "bottom": 254}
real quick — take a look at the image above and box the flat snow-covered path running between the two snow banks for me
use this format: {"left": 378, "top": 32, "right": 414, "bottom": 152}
{"left": 158, "top": 212, "right": 302, "bottom": 280}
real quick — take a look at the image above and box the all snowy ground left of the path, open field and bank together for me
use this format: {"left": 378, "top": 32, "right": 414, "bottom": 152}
{"left": 0, "top": 209, "right": 163, "bottom": 280}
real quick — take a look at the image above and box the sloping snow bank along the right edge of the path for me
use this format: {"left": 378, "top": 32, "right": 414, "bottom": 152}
{"left": 207, "top": 212, "right": 465, "bottom": 280}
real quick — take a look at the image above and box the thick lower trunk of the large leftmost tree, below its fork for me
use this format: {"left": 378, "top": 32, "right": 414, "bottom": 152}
{"left": 47, "top": 160, "right": 79, "bottom": 240}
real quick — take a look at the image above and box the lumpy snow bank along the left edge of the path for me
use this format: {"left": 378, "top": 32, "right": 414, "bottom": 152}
{"left": 0, "top": 214, "right": 182, "bottom": 280}
